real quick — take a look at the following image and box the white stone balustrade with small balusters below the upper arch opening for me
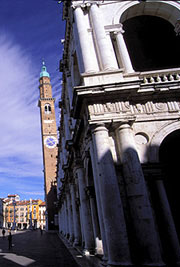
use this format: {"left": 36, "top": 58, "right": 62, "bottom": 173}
{"left": 139, "top": 69, "right": 180, "bottom": 85}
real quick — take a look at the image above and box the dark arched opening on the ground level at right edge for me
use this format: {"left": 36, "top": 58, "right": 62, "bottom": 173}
{"left": 159, "top": 130, "right": 180, "bottom": 240}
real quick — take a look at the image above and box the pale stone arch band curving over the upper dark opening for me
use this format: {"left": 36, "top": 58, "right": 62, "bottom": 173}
{"left": 113, "top": 1, "right": 180, "bottom": 25}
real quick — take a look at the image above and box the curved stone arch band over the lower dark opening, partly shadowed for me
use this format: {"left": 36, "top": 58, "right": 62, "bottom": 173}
{"left": 148, "top": 121, "right": 180, "bottom": 163}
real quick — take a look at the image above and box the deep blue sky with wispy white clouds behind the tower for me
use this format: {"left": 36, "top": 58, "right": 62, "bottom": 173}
{"left": 0, "top": 0, "right": 64, "bottom": 199}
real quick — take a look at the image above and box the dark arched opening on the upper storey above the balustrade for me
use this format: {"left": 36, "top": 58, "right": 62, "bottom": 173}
{"left": 123, "top": 15, "right": 180, "bottom": 71}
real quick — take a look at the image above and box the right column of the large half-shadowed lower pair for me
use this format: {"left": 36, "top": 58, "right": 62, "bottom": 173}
{"left": 117, "top": 123, "right": 164, "bottom": 267}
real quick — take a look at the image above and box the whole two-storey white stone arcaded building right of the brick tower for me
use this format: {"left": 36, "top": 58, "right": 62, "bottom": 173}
{"left": 57, "top": 0, "right": 180, "bottom": 267}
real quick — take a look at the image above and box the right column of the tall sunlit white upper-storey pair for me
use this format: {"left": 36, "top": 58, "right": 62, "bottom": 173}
{"left": 90, "top": 4, "right": 118, "bottom": 70}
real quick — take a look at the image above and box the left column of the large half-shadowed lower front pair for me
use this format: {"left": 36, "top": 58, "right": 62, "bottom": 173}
{"left": 92, "top": 124, "right": 131, "bottom": 266}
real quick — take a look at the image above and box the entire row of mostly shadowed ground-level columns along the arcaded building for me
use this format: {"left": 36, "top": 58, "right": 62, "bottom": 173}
{"left": 60, "top": 123, "right": 180, "bottom": 267}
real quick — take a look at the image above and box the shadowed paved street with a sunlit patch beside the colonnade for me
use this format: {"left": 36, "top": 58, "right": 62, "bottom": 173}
{"left": 0, "top": 230, "right": 78, "bottom": 267}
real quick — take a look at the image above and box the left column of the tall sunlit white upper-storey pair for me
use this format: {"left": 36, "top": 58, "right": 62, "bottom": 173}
{"left": 74, "top": 6, "right": 99, "bottom": 73}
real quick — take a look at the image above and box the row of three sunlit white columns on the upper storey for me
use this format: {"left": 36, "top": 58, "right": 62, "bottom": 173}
{"left": 74, "top": 3, "right": 134, "bottom": 73}
